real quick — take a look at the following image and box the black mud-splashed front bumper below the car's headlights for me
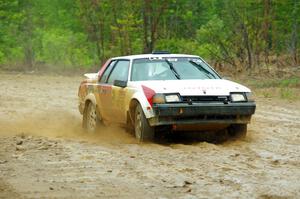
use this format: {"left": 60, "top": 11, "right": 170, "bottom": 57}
{"left": 149, "top": 102, "right": 256, "bottom": 126}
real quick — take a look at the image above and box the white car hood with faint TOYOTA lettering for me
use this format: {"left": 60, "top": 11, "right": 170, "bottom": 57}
{"left": 135, "top": 79, "right": 251, "bottom": 96}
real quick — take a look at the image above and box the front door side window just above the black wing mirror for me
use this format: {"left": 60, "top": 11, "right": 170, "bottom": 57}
{"left": 107, "top": 60, "right": 129, "bottom": 84}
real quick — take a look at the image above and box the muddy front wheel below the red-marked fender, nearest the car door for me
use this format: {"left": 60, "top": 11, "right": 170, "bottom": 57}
{"left": 134, "top": 104, "right": 154, "bottom": 142}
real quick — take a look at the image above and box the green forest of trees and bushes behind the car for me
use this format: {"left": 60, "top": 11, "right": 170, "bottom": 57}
{"left": 0, "top": 0, "right": 300, "bottom": 73}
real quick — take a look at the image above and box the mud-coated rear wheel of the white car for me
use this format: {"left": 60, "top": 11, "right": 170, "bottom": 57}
{"left": 82, "top": 102, "right": 101, "bottom": 133}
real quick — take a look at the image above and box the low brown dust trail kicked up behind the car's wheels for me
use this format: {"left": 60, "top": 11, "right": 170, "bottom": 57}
{"left": 0, "top": 111, "right": 136, "bottom": 144}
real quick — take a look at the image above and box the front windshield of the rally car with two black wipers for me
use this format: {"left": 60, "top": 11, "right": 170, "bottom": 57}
{"left": 131, "top": 57, "right": 220, "bottom": 81}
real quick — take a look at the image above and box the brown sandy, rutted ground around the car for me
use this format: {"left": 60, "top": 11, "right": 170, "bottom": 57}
{"left": 0, "top": 73, "right": 300, "bottom": 198}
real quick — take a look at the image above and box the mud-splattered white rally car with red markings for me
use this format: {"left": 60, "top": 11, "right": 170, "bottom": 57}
{"left": 78, "top": 52, "right": 256, "bottom": 141}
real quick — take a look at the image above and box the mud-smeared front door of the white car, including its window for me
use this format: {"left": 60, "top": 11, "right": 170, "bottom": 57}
{"left": 107, "top": 60, "right": 130, "bottom": 123}
